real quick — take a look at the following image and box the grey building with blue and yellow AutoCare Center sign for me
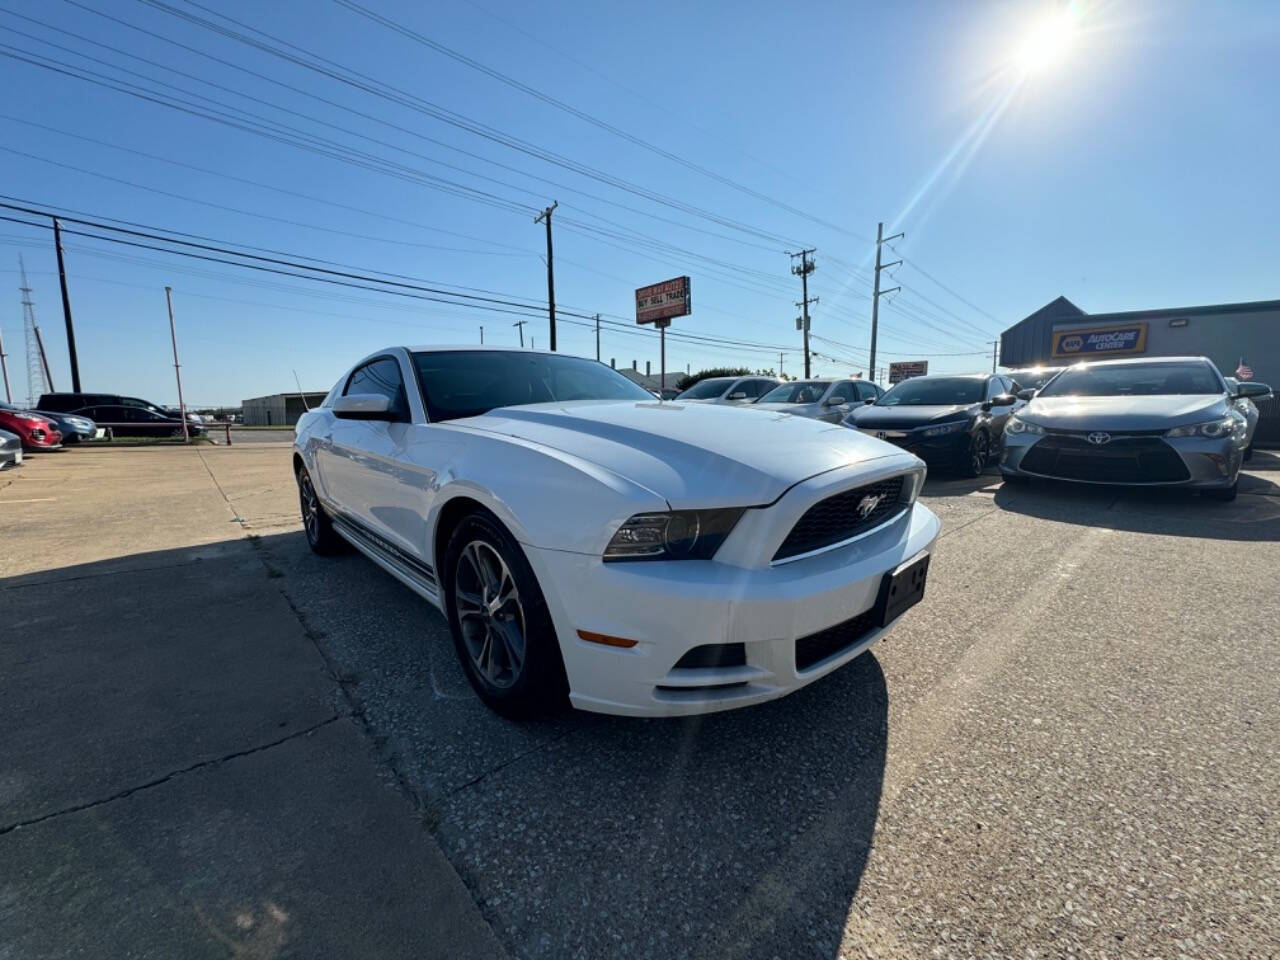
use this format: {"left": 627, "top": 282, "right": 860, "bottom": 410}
{"left": 1000, "top": 297, "right": 1280, "bottom": 387}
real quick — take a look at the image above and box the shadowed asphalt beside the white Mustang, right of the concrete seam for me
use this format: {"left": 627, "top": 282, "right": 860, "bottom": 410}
{"left": 252, "top": 534, "right": 892, "bottom": 957}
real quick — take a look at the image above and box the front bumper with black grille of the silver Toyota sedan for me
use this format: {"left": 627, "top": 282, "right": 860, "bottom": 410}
{"left": 1000, "top": 431, "right": 1244, "bottom": 489}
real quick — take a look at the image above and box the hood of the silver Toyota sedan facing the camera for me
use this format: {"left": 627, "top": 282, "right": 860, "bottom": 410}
{"left": 1018, "top": 394, "right": 1228, "bottom": 431}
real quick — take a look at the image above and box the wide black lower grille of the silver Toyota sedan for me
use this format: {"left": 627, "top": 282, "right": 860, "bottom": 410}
{"left": 1019, "top": 434, "right": 1190, "bottom": 484}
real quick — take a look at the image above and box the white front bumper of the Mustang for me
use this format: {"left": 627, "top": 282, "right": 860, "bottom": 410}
{"left": 526, "top": 484, "right": 941, "bottom": 717}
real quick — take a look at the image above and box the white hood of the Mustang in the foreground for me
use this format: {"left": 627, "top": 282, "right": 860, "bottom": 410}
{"left": 449, "top": 401, "right": 901, "bottom": 508}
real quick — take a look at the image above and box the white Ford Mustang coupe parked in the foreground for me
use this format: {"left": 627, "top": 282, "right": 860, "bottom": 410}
{"left": 293, "top": 347, "right": 940, "bottom": 716}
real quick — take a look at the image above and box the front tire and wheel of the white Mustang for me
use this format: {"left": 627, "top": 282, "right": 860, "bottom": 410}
{"left": 443, "top": 511, "right": 568, "bottom": 719}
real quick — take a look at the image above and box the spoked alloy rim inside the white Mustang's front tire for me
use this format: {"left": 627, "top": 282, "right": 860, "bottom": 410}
{"left": 453, "top": 540, "right": 526, "bottom": 689}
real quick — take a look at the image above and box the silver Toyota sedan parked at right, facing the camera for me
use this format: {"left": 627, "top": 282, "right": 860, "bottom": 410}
{"left": 1000, "top": 357, "right": 1270, "bottom": 500}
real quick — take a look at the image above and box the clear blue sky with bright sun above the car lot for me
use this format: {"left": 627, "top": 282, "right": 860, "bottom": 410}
{"left": 0, "top": 0, "right": 1280, "bottom": 404}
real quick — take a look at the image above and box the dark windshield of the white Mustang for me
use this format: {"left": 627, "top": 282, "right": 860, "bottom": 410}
{"left": 413, "top": 351, "right": 654, "bottom": 421}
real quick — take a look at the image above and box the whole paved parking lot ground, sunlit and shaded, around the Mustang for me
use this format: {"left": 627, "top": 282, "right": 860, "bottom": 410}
{"left": 0, "top": 443, "right": 1280, "bottom": 957}
